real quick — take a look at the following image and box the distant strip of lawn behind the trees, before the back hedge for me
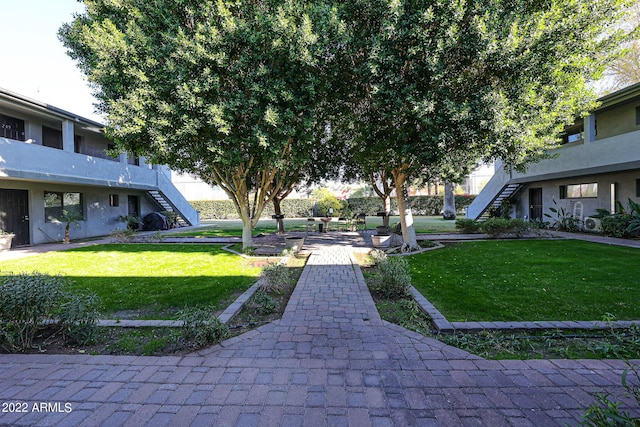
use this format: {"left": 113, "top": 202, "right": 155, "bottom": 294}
{"left": 171, "top": 216, "right": 456, "bottom": 237}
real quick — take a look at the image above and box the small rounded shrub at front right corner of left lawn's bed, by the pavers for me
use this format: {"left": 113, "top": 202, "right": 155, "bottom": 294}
{"left": 178, "top": 307, "right": 229, "bottom": 347}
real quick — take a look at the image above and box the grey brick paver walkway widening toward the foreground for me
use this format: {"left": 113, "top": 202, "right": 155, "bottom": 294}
{"left": 0, "top": 236, "right": 640, "bottom": 427}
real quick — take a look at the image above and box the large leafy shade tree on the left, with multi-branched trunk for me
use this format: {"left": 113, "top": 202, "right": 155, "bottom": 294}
{"left": 60, "top": 0, "right": 339, "bottom": 247}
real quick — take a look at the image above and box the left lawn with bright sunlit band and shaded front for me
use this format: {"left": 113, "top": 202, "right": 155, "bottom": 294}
{"left": 0, "top": 244, "right": 261, "bottom": 318}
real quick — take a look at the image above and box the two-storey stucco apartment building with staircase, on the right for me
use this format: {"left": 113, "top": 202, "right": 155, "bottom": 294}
{"left": 467, "top": 83, "right": 640, "bottom": 227}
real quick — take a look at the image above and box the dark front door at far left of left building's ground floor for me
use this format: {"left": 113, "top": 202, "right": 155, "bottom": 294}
{"left": 0, "top": 189, "right": 31, "bottom": 246}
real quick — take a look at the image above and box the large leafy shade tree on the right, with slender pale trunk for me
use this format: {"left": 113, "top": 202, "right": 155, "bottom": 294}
{"left": 334, "top": 0, "right": 630, "bottom": 251}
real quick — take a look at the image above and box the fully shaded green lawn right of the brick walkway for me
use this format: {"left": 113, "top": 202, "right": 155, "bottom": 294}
{"left": 409, "top": 240, "right": 640, "bottom": 321}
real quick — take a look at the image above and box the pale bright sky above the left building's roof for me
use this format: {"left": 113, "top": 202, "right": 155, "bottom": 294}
{"left": 0, "top": 0, "right": 103, "bottom": 122}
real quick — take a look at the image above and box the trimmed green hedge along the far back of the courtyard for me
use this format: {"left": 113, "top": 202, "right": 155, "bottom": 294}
{"left": 190, "top": 195, "right": 475, "bottom": 219}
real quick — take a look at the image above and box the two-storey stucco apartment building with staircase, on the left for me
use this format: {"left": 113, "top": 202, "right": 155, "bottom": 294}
{"left": 0, "top": 89, "right": 199, "bottom": 247}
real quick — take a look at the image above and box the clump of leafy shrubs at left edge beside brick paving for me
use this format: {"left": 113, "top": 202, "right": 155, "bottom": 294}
{"left": 0, "top": 273, "right": 98, "bottom": 352}
